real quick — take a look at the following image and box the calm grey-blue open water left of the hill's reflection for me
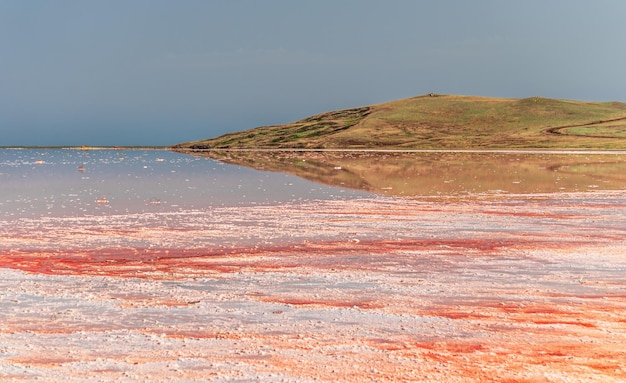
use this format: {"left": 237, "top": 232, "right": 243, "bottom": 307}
{"left": 0, "top": 149, "right": 370, "bottom": 218}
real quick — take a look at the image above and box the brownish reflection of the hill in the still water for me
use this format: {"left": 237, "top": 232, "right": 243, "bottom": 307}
{"left": 180, "top": 151, "right": 626, "bottom": 197}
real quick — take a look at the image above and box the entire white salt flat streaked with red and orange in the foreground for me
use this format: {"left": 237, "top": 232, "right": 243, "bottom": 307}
{"left": 0, "top": 191, "right": 626, "bottom": 383}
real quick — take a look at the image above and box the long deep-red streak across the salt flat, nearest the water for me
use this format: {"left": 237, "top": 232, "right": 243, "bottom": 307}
{"left": 0, "top": 239, "right": 556, "bottom": 278}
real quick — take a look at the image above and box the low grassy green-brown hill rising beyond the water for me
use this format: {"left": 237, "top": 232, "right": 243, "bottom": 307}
{"left": 174, "top": 95, "right": 626, "bottom": 149}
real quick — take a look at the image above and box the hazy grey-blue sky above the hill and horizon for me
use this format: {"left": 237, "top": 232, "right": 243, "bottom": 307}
{"left": 0, "top": 0, "right": 626, "bottom": 146}
